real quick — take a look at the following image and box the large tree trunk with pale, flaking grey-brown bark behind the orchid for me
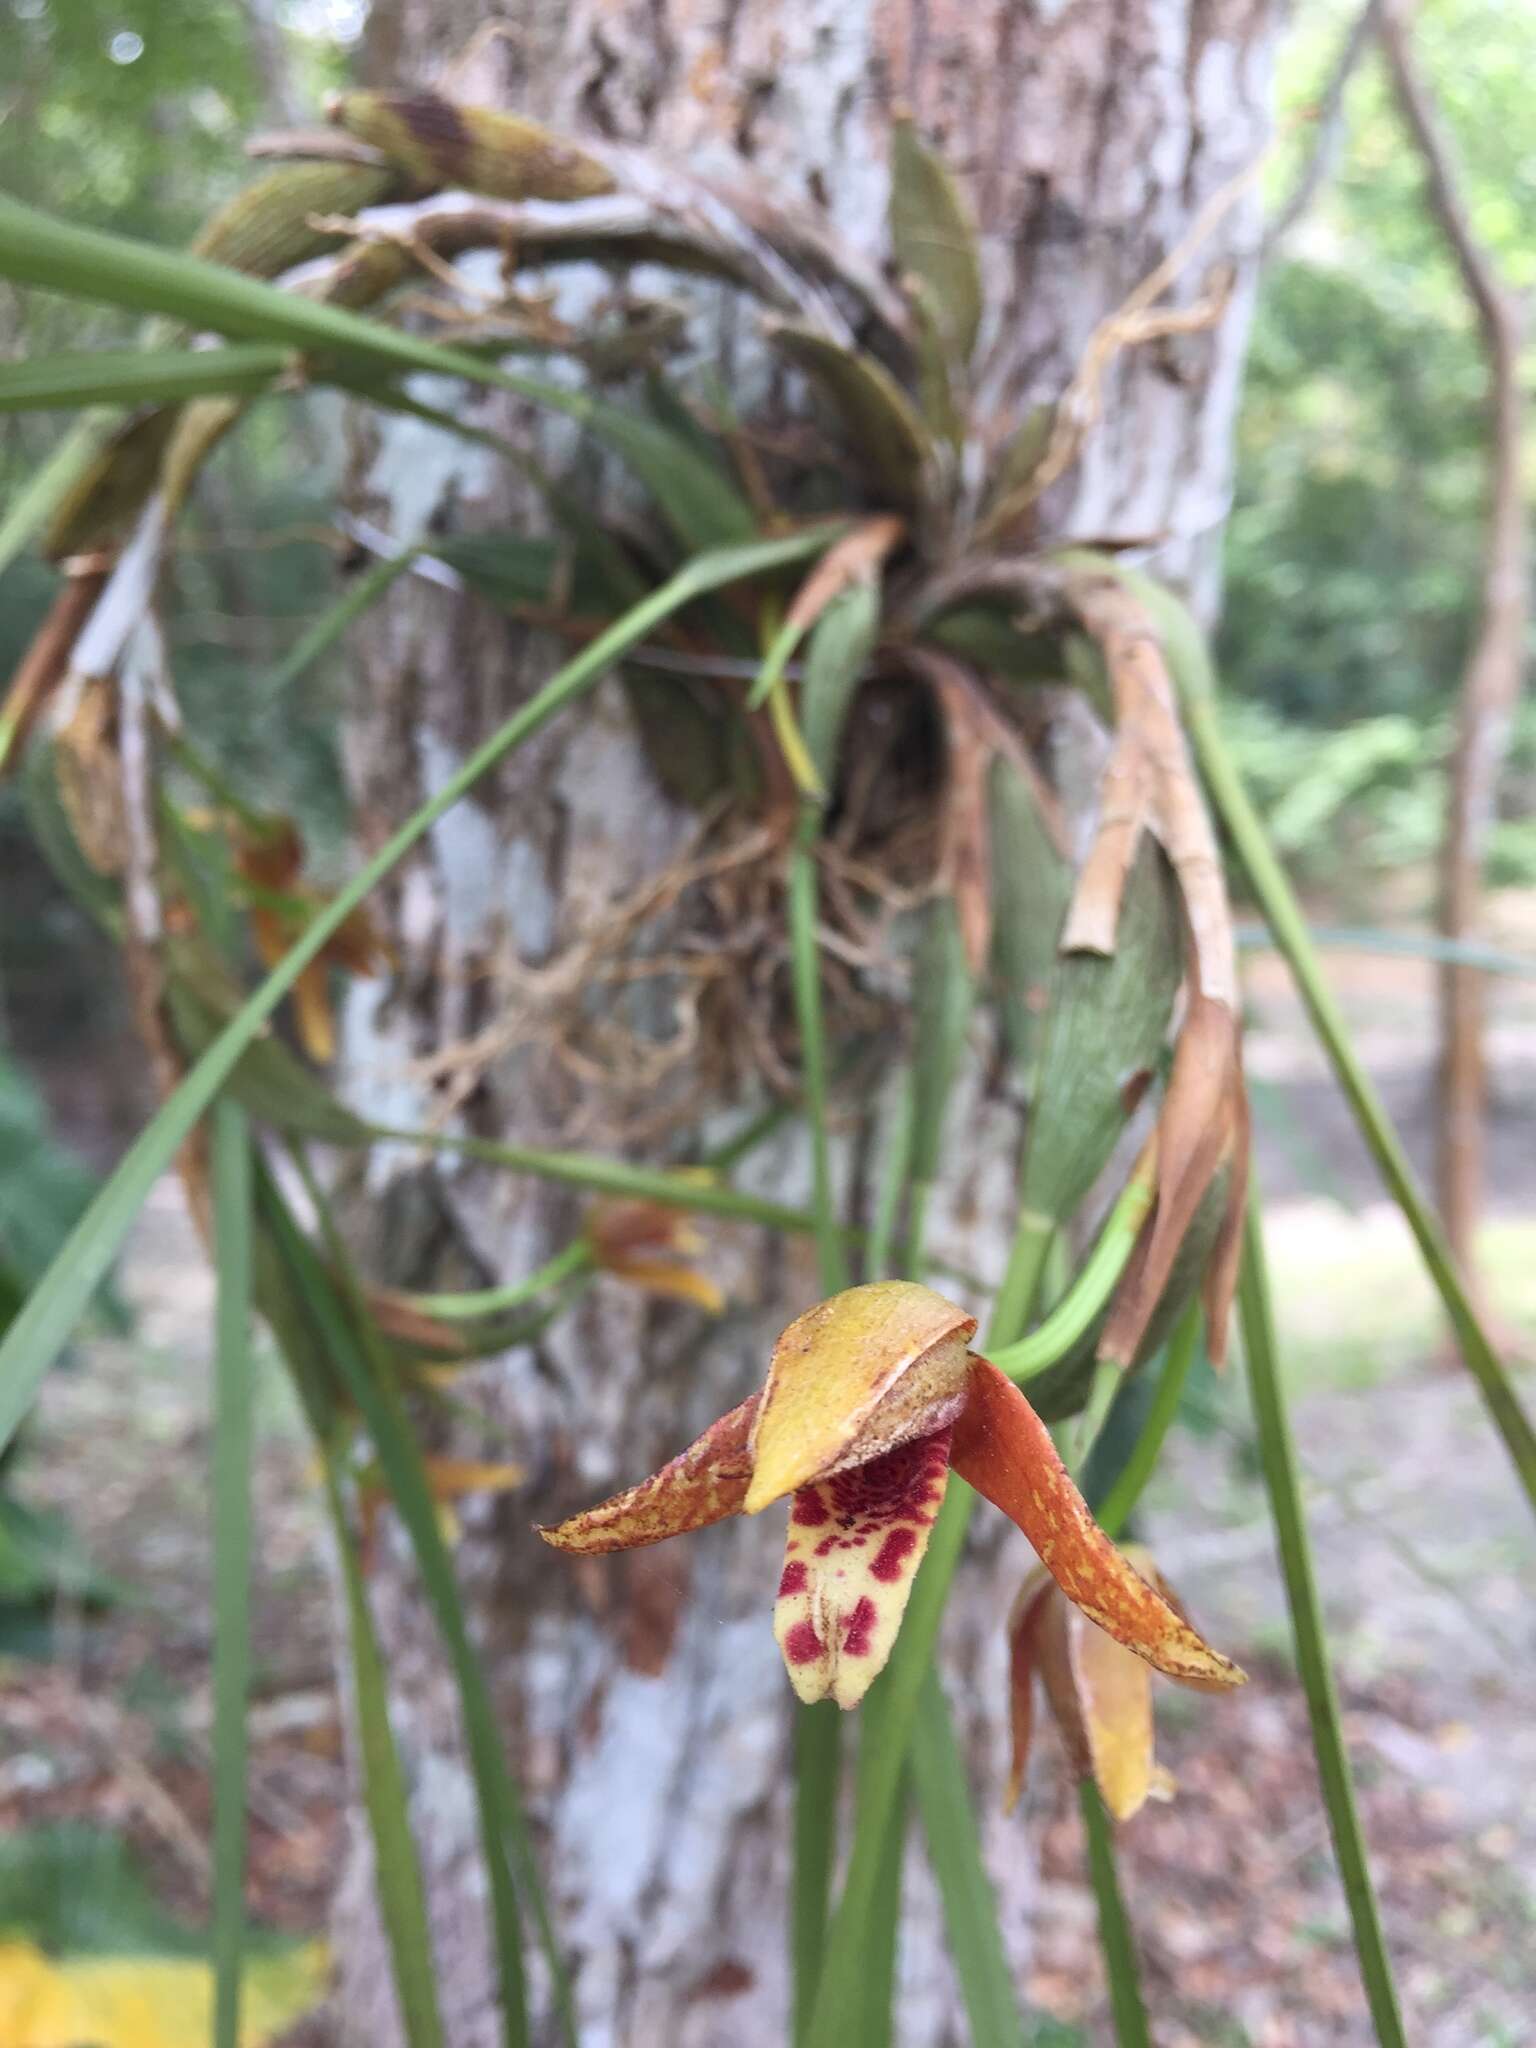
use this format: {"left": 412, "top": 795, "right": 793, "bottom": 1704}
{"left": 338, "top": 0, "right": 1278, "bottom": 2048}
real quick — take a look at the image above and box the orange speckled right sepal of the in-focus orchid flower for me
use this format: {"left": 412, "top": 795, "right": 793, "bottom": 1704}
{"left": 950, "top": 1358, "right": 1245, "bottom": 1690}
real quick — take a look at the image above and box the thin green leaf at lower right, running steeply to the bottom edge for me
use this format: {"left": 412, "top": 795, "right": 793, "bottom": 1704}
{"left": 1237, "top": 1194, "right": 1407, "bottom": 2048}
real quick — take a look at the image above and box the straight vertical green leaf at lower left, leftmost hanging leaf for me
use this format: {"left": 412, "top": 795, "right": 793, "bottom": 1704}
{"left": 213, "top": 1100, "right": 254, "bottom": 2048}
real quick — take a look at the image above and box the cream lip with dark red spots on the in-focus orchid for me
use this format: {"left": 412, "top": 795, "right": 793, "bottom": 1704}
{"left": 774, "top": 1427, "right": 950, "bottom": 1706}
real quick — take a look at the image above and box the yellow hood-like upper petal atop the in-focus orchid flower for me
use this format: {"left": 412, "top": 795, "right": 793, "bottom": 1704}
{"left": 745, "top": 1280, "right": 977, "bottom": 1516}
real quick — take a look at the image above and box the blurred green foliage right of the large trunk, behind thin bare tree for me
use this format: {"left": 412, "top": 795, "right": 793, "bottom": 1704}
{"left": 1221, "top": 0, "right": 1536, "bottom": 885}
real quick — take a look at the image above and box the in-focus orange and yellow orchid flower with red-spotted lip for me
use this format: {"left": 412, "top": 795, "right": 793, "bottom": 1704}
{"left": 539, "top": 1280, "right": 1243, "bottom": 1708}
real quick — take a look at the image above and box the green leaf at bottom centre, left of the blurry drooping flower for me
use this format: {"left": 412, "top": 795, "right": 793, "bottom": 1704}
{"left": 911, "top": 1665, "right": 1024, "bottom": 2048}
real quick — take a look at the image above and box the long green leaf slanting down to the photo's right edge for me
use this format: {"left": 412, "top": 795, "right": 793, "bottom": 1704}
{"left": 1169, "top": 688, "right": 1536, "bottom": 1507}
